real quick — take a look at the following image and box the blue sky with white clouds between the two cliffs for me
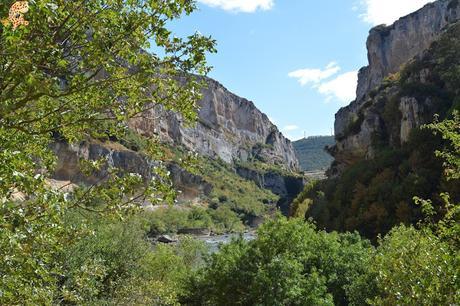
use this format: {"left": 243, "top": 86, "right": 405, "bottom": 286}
{"left": 173, "top": 0, "right": 429, "bottom": 140}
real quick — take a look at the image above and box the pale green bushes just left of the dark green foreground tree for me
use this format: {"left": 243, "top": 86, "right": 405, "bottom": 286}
{"left": 60, "top": 216, "right": 206, "bottom": 305}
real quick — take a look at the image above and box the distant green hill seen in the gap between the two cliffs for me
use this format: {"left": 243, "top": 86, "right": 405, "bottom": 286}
{"left": 292, "top": 136, "right": 335, "bottom": 171}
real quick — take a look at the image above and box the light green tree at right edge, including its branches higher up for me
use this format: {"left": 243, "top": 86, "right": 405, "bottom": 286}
{"left": 349, "top": 111, "right": 460, "bottom": 305}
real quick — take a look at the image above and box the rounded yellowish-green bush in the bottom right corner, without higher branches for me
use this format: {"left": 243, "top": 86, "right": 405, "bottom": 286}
{"left": 349, "top": 226, "right": 460, "bottom": 305}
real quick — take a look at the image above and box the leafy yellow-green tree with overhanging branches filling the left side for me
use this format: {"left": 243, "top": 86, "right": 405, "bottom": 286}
{"left": 0, "top": 0, "right": 214, "bottom": 304}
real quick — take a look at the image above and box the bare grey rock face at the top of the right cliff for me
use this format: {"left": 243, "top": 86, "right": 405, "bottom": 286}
{"left": 357, "top": 0, "right": 460, "bottom": 100}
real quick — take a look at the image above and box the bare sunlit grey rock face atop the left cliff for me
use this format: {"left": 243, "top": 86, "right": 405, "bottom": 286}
{"left": 130, "top": 79, "right": 298, "bottom": 170}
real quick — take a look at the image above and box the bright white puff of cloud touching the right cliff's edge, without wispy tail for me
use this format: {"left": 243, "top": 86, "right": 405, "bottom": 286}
{"left": 317, "top": 71, "right": 358, "bottom": 104}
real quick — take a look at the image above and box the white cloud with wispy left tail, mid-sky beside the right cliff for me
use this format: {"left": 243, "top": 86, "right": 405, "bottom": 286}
{"left": 288, "top": 62, "right": 358, "bottom": 103}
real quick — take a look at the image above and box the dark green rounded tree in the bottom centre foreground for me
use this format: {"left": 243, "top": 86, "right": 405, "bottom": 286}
{"left": 183, "top": 217, "right": 372, "bottom": 305}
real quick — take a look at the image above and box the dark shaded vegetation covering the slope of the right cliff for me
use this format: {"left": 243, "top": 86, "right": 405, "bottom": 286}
{"left": 297, "top": 24, "right": 460, "bottom": 239}
